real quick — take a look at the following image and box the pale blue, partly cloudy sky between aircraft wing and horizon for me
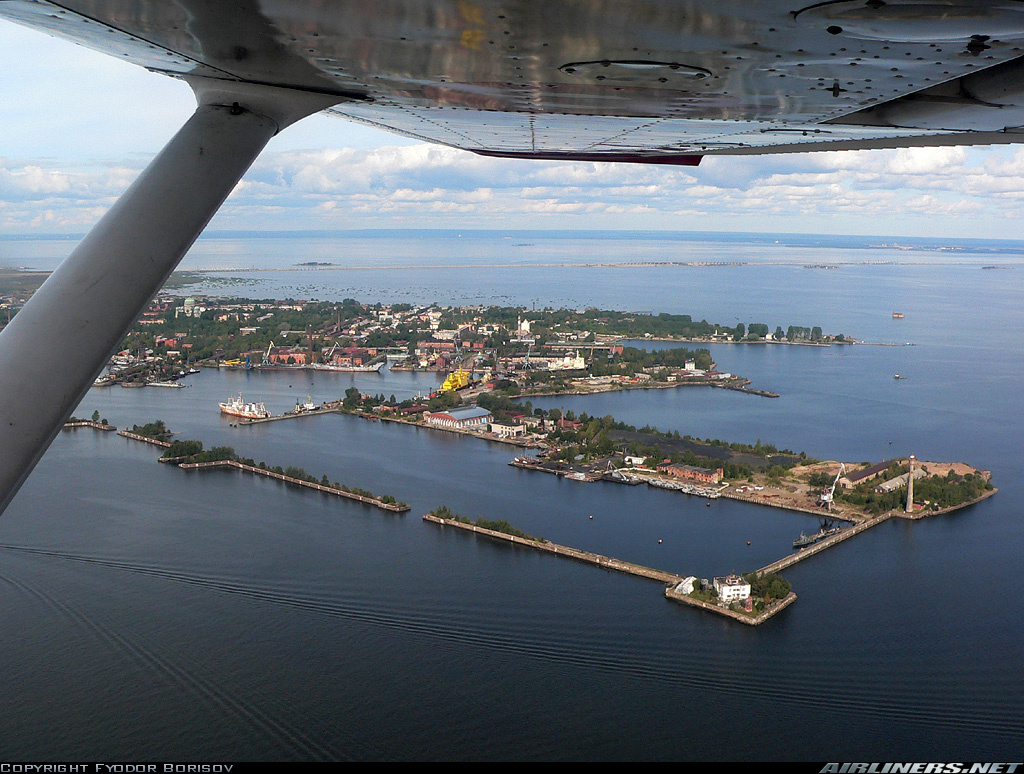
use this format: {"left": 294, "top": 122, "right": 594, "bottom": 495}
{"left": 6, "top": 20, "right": 1024, "bottom": 239}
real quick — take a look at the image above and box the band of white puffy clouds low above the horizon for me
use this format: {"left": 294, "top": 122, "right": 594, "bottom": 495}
{"left": 0, "top": 143, "right": 1024, "bottom": 232}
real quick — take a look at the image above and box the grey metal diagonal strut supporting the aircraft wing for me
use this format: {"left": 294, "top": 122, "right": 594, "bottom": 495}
{"left": 0, "top": 79, "right": 346, "bottom": 512}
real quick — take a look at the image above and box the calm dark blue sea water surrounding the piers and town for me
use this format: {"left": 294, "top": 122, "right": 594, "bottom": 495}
{"left": 0, "top": 231, "right": 1024, "bottom": 761}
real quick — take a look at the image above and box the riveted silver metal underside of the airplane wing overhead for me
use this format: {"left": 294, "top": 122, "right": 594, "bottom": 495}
{"left": 6, "top": 0, "right": 1024, "bottom": 159}
